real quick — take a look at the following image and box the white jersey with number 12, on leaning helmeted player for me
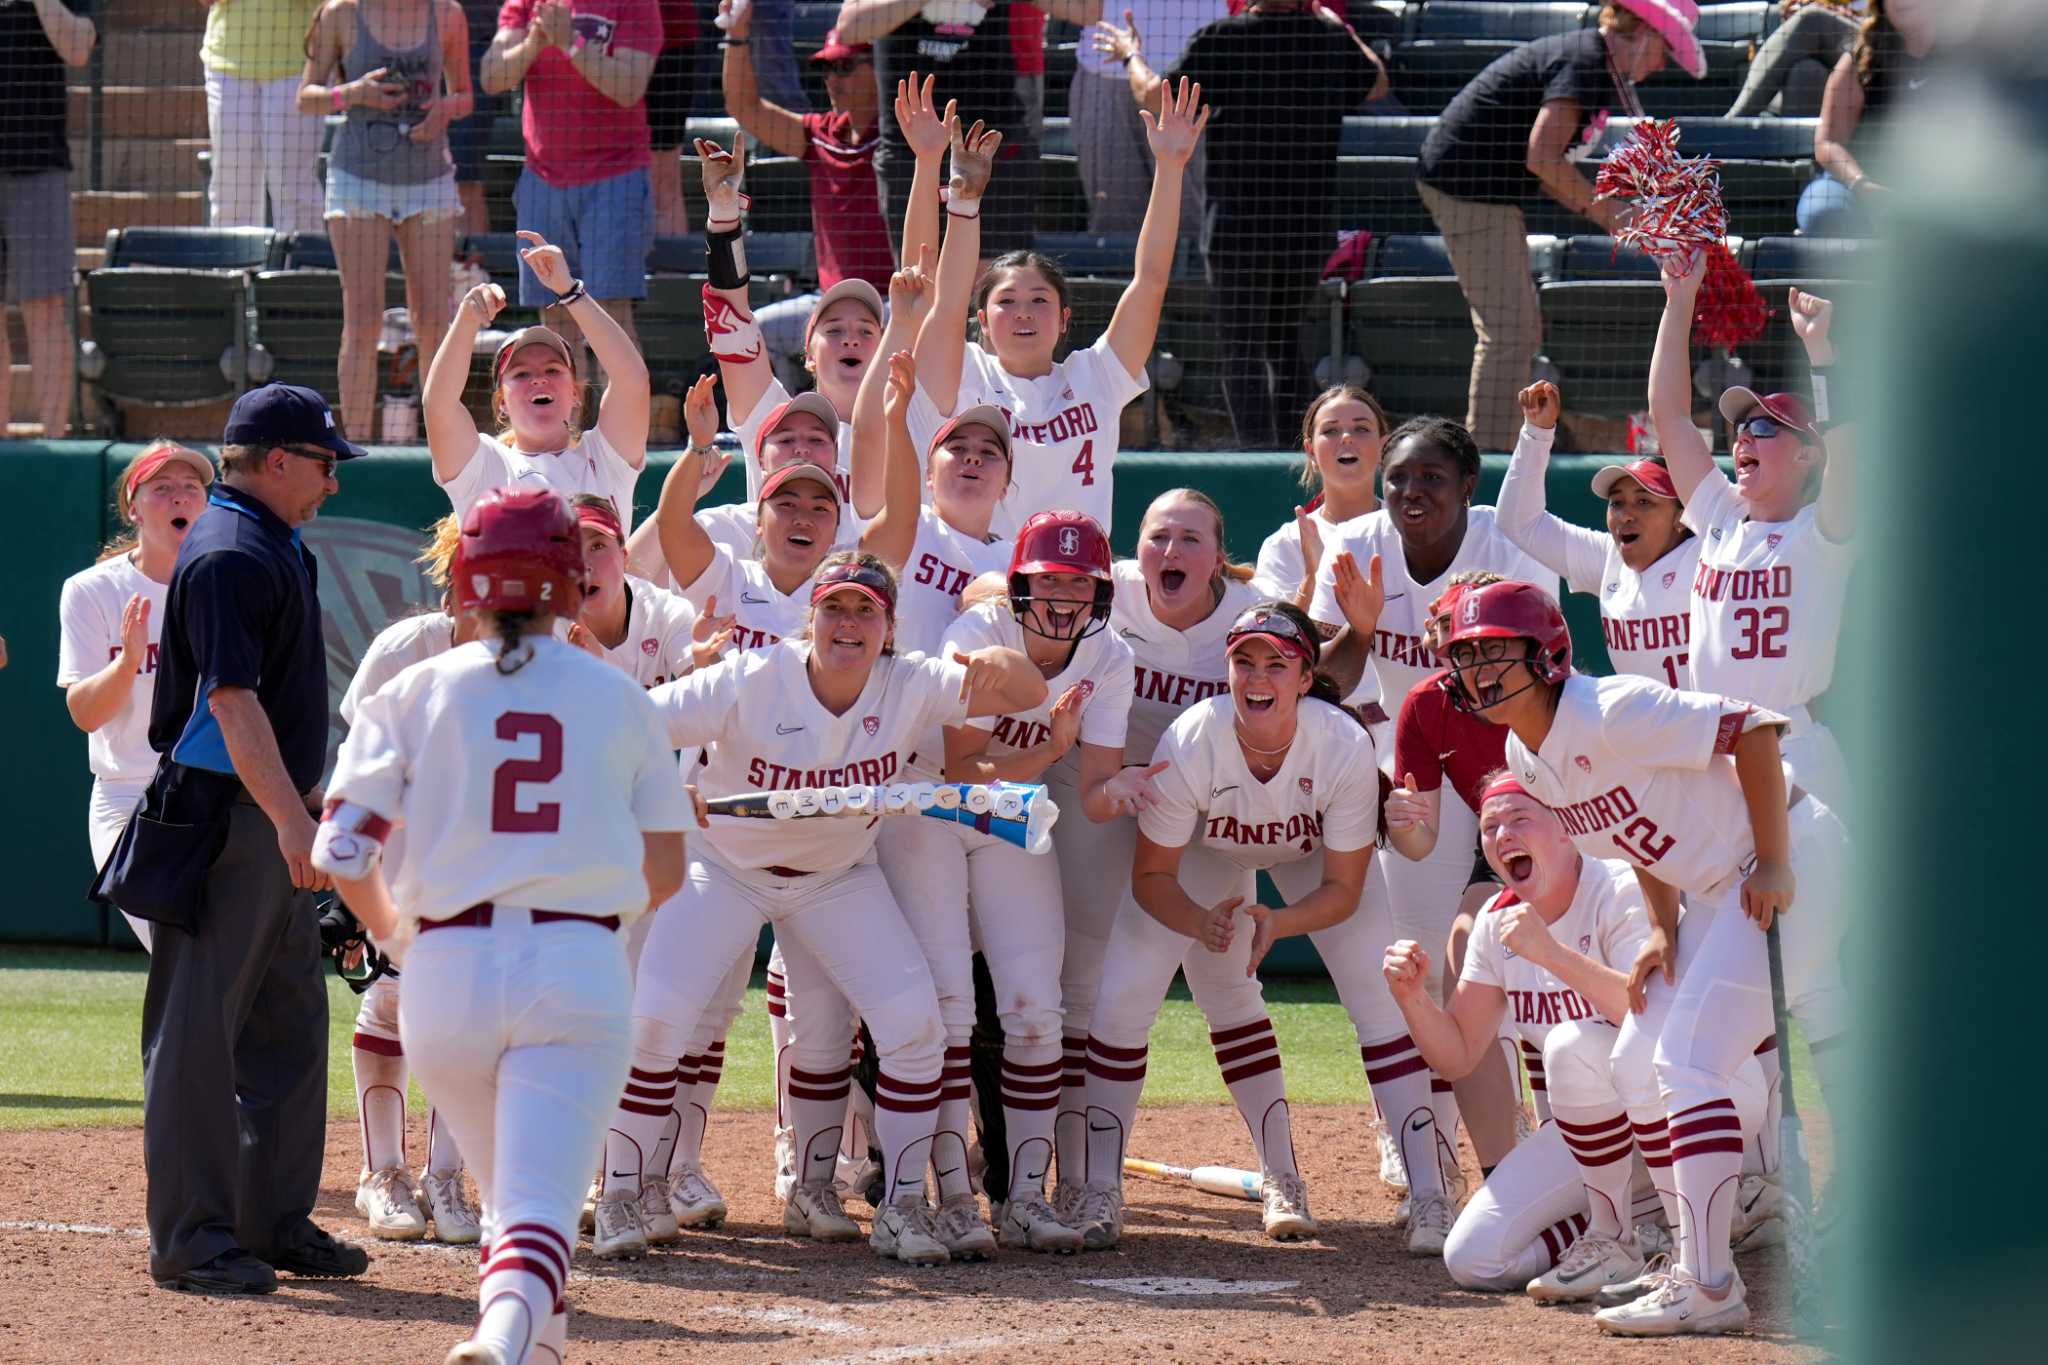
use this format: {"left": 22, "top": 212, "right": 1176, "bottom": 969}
{"left": 1507, "top": 673, "right": 1782, "bottom": 896}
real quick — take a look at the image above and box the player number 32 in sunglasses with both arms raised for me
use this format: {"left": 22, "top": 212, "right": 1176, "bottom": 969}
{"left": 1651, "top": 266, "right": 1855, "bottom": 804}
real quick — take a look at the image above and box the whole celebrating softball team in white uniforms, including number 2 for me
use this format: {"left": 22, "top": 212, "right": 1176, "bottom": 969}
{"left": 66, "top": 82, "right": 1853, "bottom": 1361}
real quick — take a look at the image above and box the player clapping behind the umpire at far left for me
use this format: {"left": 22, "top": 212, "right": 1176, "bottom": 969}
{"left": 57, "top": 440, "right": 213, "bottom": 950}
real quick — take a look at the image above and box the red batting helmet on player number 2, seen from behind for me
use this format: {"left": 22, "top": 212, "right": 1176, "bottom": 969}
{"left": 449, "top": 489, "right": 584, "bottom": 616}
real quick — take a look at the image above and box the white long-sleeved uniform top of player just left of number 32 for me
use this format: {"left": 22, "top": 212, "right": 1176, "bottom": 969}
{"left": 1495, "top": 424, "right": 1714, "bottom": 692}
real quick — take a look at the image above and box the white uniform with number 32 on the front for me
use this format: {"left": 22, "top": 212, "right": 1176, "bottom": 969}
{"left": 1686, "top": 469, "right": 1853, "bottom": 804}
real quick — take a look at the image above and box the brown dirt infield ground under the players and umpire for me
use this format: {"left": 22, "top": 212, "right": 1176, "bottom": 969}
{"left": 0, "top": 1107, "right": 1819, "bottom": 1365}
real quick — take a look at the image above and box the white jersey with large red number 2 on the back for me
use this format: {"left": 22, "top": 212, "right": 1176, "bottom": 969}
{"left": 328, "top": 636, "right": 694, "bottom": 921}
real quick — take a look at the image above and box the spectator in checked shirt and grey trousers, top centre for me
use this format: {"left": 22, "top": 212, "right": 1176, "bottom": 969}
{"left": 1067, "top": 0, "right": 1229, "bottom": 235}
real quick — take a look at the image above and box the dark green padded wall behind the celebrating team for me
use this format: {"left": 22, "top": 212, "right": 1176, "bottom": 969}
{"left": 0, "top": 442, "right": 1654, "bottom": 949}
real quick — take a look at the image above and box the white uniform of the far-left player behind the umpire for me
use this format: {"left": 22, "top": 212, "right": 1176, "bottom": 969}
{"left": 57, "top": 555, "right": 170, "bottom": 948}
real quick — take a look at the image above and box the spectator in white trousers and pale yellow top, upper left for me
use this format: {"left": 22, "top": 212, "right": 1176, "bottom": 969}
{"left": 199, "top": 0, "right": 322, "bottom": 231}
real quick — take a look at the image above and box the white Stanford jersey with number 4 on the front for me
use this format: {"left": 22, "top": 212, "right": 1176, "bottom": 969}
{"left": 909, "top": 334, "right": 1149, "bottom": 536}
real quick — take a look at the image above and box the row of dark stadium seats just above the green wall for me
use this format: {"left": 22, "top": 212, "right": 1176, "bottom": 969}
{"left": 82, "top": 227, "right": 1868, "bottom": 437}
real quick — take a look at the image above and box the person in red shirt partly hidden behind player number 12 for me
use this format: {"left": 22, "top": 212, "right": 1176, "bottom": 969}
{"left": 1386, "top": 569, "right": 1534, "bottom": 1173}
